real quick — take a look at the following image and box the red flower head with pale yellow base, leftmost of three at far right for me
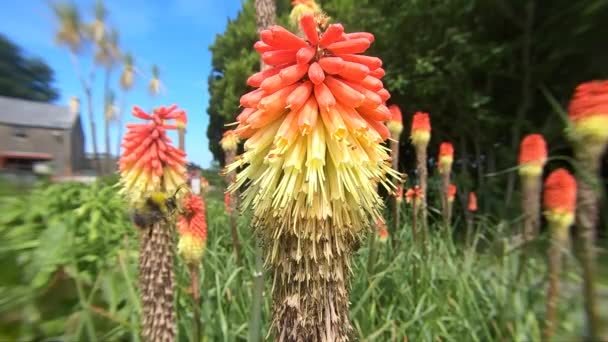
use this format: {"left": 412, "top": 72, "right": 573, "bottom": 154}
{"left": 519, "top": 134, "right": 547, "bottom": 177}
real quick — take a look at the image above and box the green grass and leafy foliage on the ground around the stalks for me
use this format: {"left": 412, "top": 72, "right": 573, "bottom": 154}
{"left": 0, "top": 184, "right": 600, "bottom": 341}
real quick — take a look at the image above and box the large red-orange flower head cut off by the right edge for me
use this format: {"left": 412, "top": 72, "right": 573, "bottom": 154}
{"left": 568, "top": 81, "right": 608, "bottom": 146}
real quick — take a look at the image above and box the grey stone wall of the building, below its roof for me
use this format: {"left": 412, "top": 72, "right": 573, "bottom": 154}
{"left": 0, "top": 124, "right": 74, "bottom": 175}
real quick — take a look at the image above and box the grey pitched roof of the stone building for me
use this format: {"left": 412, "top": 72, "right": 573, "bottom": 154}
{"left": 0, "top": 96, "right": 78, "bottom": 129}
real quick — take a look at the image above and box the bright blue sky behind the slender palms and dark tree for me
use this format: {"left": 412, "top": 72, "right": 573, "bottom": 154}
{"left": 0, "top": 0, "right": 241, "bottom": 167}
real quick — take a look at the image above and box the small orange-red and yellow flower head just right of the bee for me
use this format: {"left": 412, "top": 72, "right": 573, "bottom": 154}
{"left": 177, "top": 194, "right": 207, "bottom": 264}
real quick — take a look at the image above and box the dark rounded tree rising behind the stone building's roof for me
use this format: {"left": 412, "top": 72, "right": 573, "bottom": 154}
{"left": 0, "top": 34, "right": 59, "bottom": 102}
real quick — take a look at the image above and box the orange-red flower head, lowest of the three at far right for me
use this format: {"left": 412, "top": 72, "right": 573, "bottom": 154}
{"left": 543, "top": 169, "right": 576, "bottom": 227}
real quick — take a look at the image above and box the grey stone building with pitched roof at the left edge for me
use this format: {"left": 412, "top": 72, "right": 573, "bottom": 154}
{"left": 0, "top": 96, "right": 87, "bottom": 176}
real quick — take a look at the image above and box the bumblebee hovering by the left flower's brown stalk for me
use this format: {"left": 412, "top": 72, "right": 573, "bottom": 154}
{"left": 131, "top": 186, "right": 188, "bottom": 229}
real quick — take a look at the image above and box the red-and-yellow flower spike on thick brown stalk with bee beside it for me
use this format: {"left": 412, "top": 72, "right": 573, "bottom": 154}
{"left": 119, "top": 106, "right": 186, "bottom": 341}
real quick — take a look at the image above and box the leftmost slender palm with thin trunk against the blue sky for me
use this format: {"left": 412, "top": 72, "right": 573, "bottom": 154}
{"left": 52, "top": 3, "right": 101, "bottom": 174}
